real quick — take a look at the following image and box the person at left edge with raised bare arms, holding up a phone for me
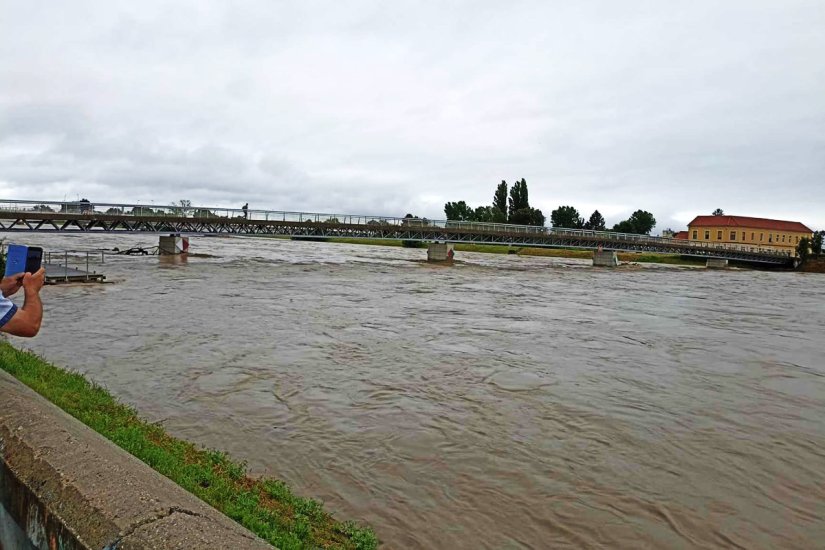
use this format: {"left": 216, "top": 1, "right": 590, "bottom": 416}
{"left": 0, "top": 267, "right": 46, "bottom": 338}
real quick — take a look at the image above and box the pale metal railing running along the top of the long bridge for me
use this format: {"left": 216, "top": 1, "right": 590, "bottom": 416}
{"left": 0, "top": 200, "right": 792, "bottom": 256}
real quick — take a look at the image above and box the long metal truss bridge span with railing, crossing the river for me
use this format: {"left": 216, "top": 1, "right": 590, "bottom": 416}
{"left": 0, "top": 200, "right": 794, "bottom": 265}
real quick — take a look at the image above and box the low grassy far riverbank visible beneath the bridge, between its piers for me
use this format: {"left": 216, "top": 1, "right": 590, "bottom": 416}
{"left": 324, "top": 237, "right": 705, "bottom": 266}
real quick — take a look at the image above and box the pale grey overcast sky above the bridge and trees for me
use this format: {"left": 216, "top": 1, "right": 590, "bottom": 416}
{"left": 0, "top": 0, "right": 825, "bottom": 231}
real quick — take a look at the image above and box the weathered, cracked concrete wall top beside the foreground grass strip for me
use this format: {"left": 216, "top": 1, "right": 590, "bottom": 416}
{"left": 0, "top": 371, "right": 272, "bottom": 550}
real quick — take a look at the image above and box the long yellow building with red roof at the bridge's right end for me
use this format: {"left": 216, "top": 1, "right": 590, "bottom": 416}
{"left": 688, "top": 215, "right": 813, "bottom": 256}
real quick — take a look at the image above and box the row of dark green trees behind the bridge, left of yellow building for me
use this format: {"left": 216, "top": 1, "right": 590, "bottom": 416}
{"left": 444, "top": 178, "right": 656, "bottom": 235}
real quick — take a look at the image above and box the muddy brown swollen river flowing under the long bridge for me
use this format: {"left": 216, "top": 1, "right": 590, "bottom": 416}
{"left": 8, "top": 234, "right": 825, "bottom": 549}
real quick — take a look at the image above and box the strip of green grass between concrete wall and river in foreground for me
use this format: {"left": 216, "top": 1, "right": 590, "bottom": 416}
{"left": 0, "top": 342, "right": 378, "bottom": 550}
